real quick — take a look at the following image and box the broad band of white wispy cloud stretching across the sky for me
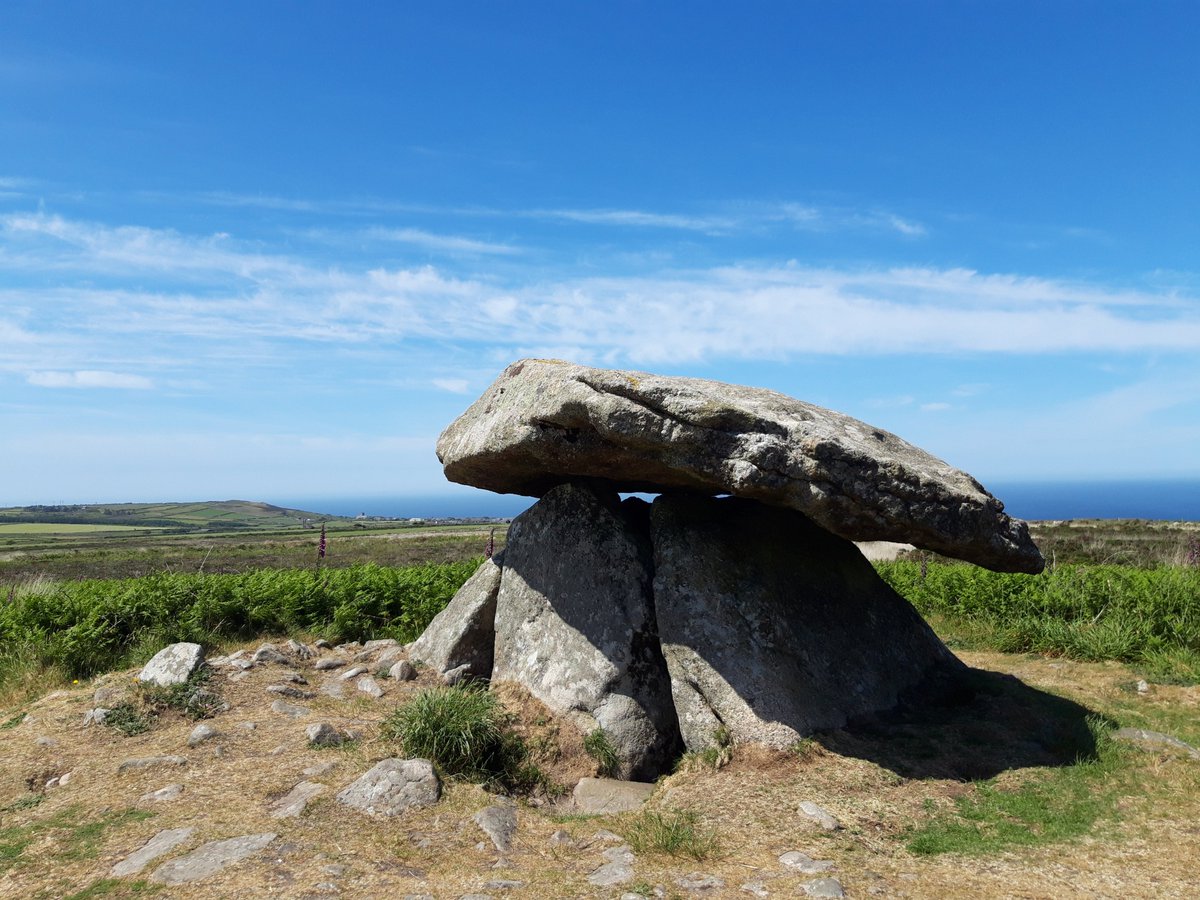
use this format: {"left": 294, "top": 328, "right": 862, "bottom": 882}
{"left": 0, "top": 214, "right": 1200, "bottom": 374}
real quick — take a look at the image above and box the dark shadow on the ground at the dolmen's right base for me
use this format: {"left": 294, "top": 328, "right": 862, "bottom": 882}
{"left": 812, "top": 668, "right": 1111, "bottom": 781}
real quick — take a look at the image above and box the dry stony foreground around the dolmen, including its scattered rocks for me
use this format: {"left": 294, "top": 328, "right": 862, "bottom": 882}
{"left": 0, "top": 642, "right": 1200, "bottom": 899}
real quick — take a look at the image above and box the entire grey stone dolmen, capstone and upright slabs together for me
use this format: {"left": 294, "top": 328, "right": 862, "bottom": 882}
{"left": 410, "top": 360, "right": 1044, "bottom": 779}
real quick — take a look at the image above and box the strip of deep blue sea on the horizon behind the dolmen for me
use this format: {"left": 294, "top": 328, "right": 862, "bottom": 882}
{"left": 270, "top": 480, "right": 1200, "bottom": 522}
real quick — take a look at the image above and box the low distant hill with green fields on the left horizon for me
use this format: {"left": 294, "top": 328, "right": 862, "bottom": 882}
{"left": 0, "top": 500, "right": 346, "bottom": 532}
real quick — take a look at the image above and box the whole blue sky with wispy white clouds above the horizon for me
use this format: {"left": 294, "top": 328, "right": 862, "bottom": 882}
{"left": 0, "top": 0, "right": 1200, "bottom": 505}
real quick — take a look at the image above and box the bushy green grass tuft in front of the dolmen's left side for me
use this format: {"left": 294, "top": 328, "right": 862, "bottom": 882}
{"left": 379, "top": 686, "right": 554, "bottom": 792}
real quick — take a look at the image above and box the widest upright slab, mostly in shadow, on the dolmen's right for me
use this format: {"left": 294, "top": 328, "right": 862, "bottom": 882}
{"left": 650, "top": 494, "right": 961, "bottom": 750}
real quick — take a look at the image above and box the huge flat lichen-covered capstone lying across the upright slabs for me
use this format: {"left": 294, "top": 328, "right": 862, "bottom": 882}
{"left": 437, "top": 359, "right": 1044, "bottom": 572}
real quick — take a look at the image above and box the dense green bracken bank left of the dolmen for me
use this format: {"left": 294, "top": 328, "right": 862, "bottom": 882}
{"left": 0, "top": 558, "right": 479, "bottom": 689}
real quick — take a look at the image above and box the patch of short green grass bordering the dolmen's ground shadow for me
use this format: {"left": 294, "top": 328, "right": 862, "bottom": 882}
{"left": 905, "top": 720, "right": 1129, "bottom": 856}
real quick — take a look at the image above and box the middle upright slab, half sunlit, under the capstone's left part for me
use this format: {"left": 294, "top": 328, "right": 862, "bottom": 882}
{"left": 492, "top": 484, "right": 679, "bottom": 779}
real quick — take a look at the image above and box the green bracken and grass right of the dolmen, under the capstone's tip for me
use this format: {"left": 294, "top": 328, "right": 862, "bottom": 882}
{"left": 876, "top": 560, "right": 1200, "bottom": 684}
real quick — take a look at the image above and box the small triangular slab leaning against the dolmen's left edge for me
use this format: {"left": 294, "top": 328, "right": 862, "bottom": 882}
{"left": 408, "top": 554, "right": 503, "bottom": 678}
